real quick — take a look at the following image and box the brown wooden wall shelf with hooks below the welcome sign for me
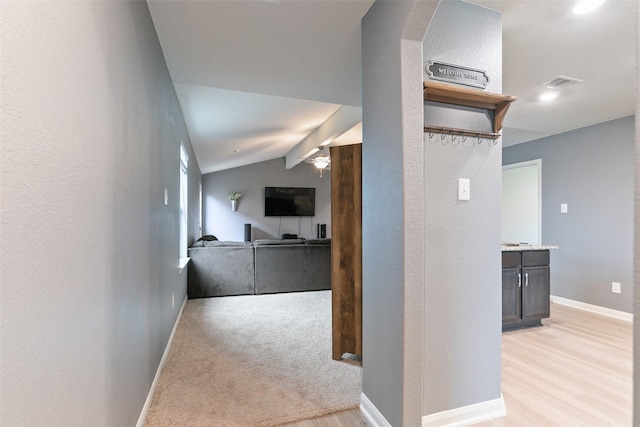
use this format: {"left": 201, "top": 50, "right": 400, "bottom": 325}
{"left": 424, "top": 81, "right": 517, "bottom": 138}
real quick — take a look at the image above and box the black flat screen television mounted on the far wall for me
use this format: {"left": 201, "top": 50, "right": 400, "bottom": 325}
{"left": 264, "top": 187, "right": 316, "bottom": 216}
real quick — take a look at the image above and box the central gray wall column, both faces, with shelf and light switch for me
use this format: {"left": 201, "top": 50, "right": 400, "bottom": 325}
{"left": 362, "top": 1, "right": 502, "bottom": 426}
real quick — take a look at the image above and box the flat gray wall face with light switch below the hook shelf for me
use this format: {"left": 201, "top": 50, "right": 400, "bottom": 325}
{"left": 423, "top": 1, "right": 502, "bottom": 414}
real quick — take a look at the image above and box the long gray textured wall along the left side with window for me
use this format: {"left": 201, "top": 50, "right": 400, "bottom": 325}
{"left": 0, "top": 1, "right": 200, "bottom": 426}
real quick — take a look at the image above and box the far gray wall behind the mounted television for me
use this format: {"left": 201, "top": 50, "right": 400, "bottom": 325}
{"left": 202, "top": 158, "right": 331, "bottom": 241}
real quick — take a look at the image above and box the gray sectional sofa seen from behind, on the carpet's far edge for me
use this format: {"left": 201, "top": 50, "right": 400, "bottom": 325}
{"left": 187, "top": 239, "right": 331, "bottom": 298}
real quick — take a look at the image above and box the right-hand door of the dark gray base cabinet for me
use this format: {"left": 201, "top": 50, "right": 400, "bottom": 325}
{"left": 522, "top": 267, "right": 550, "bottom": 320}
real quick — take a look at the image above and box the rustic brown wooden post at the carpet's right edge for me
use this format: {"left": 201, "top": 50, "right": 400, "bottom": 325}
{"left": 330, "top": 144, "right": 362, "bottom": 360}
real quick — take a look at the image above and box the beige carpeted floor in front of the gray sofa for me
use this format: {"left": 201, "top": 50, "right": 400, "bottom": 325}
{"left": 145, "top": 291, "right": 362, "bottom": 427}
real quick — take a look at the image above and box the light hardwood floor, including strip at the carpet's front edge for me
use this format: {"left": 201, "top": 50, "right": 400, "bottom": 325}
{"left": 289, "top": 304, "right": 633, "bottom": 427}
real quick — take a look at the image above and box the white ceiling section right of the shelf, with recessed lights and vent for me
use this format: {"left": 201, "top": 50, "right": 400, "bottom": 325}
{"left": 470, "top": 0, "right": 637, "bottom": 145}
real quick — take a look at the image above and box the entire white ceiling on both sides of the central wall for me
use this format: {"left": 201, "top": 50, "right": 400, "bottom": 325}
{"left": 148, "top": 0, "right": 636, "bottom": 173}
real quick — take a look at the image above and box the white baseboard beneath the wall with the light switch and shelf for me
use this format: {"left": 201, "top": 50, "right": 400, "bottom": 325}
{"left": 422, "top": 396, "right": 507, "bottom": 427}
